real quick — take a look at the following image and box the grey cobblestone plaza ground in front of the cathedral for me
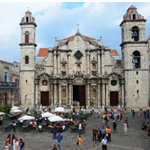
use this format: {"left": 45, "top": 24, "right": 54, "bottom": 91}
{"left": 0, "top": 112, "right": 150, "bottom": 150}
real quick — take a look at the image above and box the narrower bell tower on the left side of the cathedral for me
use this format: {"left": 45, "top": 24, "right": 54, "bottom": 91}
{"left": 19, "top": 10, "right": 37, "bottom": 107}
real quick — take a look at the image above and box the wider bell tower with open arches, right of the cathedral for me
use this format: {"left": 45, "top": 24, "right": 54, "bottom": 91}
{"left": 120, "top": 5, "right": 149, "bottom": 108}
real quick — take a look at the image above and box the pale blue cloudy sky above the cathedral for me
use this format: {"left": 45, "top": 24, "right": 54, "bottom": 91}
{"left": 0, "top": 2, "right": 150, "bottom": 61}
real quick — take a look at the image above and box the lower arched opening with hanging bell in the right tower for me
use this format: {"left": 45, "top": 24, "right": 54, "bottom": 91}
{"left": 132, "top": 51, "right": 140, "bottom": 68}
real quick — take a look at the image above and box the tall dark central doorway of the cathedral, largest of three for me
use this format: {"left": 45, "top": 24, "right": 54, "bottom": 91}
{"left": 73, "top": 85, "right": 85, "bottom": 106}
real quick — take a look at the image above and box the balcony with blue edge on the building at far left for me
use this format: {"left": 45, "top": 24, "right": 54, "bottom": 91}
{"left": 0, "top": 81, "right": 17, "bottom": 89}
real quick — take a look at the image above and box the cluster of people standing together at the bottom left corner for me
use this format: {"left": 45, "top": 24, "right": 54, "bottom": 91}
{"left": 4, "top": 134, "right": 25, "bottom": 150}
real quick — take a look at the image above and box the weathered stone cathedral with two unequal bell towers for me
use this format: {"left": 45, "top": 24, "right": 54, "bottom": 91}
{"left": 19, "top": 5, "right": 149, "bottom": 108}
